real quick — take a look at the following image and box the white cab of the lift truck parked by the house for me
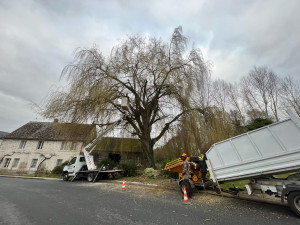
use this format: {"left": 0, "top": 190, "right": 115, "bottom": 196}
{"left": 62, "top": 155, "right": 87, "bottom": 180}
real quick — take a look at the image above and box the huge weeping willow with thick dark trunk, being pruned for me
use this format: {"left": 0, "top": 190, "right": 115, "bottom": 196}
{"left": 43, "top": 27, "right": 207, "bottom": 167}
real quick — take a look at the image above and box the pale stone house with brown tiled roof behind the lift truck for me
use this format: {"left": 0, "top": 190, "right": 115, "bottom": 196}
{"left": 0, "top": 120, "right": 96, "bottom": 174}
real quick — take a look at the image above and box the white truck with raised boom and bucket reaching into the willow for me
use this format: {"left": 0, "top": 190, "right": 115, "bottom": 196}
{"left": 62, "top": 97, "right": 128, "bottom": 182}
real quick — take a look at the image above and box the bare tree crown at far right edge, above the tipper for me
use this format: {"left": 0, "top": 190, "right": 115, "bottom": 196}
{"left": 282, "top": 76, "right": 300, "bottom": 116}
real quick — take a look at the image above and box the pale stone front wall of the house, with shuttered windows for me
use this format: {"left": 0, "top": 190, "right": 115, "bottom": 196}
{"left": 0, "top": 139, "right": 83, "bottom": 173}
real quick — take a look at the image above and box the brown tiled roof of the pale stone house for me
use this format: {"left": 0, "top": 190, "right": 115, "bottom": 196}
{"left": 4, "top": 122, "right": 95, "bottom": 141}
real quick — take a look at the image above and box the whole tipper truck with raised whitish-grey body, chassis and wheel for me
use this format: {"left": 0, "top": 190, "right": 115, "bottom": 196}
{"left": 206, "top": 112, "right": 300, "bottom": 216}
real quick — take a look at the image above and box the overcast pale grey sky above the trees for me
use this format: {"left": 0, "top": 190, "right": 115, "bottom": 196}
{"left": 0, "top": 0, "right": 300, "bottom": 132}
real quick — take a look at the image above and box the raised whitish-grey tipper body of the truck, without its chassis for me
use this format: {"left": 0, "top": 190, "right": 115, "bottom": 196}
{"left": 206, "top": 110, "right": 300, "bottom": 182}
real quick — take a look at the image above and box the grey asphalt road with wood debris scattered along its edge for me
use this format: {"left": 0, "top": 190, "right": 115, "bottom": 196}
{"left": 0, "top": 177, "right": 300, "bottom": 225}
